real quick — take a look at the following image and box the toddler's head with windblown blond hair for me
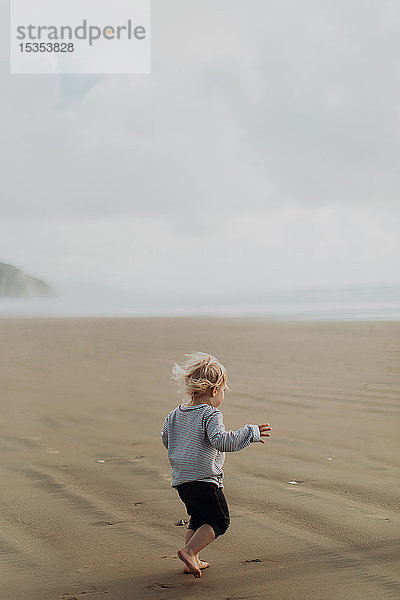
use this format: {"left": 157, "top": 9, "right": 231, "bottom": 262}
{"left": 172, "top": 352, "right": 229, "bottom": 402}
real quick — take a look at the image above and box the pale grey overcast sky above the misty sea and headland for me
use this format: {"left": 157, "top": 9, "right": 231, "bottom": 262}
{"left": 0, "top": 0, "right": 400, "bottom": 294}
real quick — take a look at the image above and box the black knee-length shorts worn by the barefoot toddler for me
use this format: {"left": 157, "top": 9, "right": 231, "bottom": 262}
{"left": 176, "top": 481, "right": 230, "bottom": 537}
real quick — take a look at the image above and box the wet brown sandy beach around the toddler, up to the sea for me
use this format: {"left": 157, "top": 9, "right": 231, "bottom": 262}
{"left": 0, "top": 318, "right": 400, "bottom": 600}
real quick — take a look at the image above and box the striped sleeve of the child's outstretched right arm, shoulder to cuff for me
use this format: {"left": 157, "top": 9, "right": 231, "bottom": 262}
{"left": 205, "top": 410, "right": 261, "bottom": 452}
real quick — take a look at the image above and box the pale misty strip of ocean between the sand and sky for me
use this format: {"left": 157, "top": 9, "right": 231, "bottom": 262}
{"left": 0, "top": 285, "right": 400, "bottom": 321}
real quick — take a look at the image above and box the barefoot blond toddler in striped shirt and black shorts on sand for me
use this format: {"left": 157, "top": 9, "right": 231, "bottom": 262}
{"left": 161, "top": 352, "right": 271, "bottom": 577}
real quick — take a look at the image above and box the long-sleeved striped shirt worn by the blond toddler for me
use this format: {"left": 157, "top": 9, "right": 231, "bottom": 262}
{"left": 161, "top": 404, "right": 260, "bottom": 487}
